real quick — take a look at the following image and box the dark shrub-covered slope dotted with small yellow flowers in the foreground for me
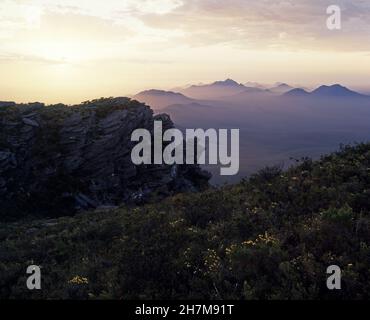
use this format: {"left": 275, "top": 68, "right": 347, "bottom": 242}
{"left": 0, "top": 144, "right": 370, "bottom": 299}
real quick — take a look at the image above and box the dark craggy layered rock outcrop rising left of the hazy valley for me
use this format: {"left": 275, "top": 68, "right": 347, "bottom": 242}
{"left": 0, "top": 98, "right": 210, "bottom": 219}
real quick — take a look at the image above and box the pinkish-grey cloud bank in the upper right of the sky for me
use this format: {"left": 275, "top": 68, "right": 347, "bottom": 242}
{"left": 140, "top": 0, "right": 370, "bottom": 51}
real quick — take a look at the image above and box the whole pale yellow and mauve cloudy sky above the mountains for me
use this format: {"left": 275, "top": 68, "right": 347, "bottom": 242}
{"left": 0, "top": 0, "right": 370, "bottom": 104}
